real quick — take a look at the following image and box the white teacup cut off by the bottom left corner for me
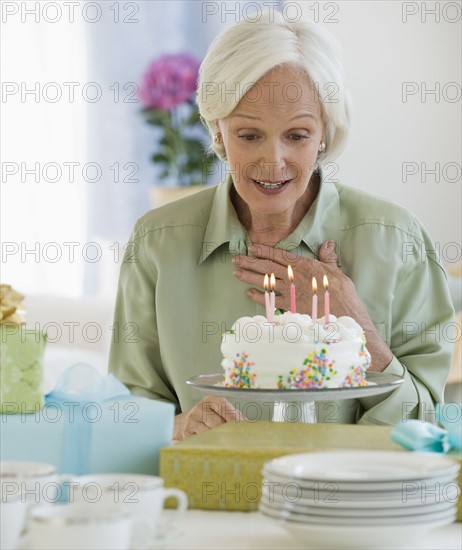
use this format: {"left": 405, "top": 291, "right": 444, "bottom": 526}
{"left": 0, "top": 489, "right": 27, "bottom": 550}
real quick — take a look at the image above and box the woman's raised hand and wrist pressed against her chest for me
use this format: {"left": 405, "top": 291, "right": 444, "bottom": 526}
{"left": 233, "top": 241, "right": 393, "bottom": 372}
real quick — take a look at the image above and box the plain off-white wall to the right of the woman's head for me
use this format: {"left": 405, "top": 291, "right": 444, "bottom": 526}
{"left": 299, "top": 1, "right": 462, "bottom": 264}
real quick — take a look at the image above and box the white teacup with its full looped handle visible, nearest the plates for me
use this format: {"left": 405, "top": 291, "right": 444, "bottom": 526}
{"left": 70, "top": 473, "right": 188, "bottom": 540}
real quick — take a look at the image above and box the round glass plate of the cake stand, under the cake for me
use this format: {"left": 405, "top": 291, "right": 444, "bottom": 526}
{"left": 186, "top": 372, "right": 404, "bottom": 403}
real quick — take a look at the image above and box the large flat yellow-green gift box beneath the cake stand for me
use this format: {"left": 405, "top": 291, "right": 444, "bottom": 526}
{"left": 160, "top": 422, "right": 462, "bottom": 521}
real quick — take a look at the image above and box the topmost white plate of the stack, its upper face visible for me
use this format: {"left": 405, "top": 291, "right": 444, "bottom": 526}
{"left": 264, "top": 450, "right": 460, "bottom": 488}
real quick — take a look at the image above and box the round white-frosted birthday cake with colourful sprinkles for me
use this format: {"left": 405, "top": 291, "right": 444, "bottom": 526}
{"left": 221, "top": 312, "right": 371, "bottom": 390}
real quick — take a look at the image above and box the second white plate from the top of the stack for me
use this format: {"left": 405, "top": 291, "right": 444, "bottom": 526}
{"left": 261, "top": 468, "right": 457, "bottom": 498}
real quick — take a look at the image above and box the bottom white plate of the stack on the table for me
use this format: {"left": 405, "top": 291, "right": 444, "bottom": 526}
{"left": 274, "top": 518, "right": 458, "bottom": 550}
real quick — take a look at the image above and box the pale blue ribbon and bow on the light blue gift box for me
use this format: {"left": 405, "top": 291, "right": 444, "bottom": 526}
{"left": 45, "top": 363, "right": 130, "bottom": 475}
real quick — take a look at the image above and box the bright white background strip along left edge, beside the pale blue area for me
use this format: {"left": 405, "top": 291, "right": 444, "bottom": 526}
{"left": 0, "top": 10, "right": 86, "bottom": 296}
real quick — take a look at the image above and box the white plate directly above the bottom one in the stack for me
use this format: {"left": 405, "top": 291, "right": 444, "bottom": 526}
{"left": 258, "top": 501, "right": 457, "bottom": 525}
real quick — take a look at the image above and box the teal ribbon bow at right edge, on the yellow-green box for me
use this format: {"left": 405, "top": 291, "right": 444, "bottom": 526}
{"left": 391, "top": 403, "right": 462, "bottom": 453}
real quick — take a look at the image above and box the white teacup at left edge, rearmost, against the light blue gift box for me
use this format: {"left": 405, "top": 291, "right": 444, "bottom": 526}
{"left": 0, "top": 460, "right": 71, "bottom": 506}
